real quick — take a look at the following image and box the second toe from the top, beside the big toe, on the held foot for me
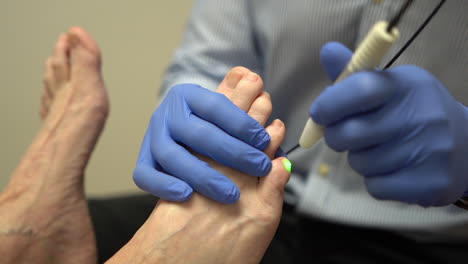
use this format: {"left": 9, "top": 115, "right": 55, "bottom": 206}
{"left": 232, "top": 72, "right": 263, "bottom": 112}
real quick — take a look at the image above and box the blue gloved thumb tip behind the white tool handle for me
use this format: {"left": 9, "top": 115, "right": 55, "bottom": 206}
{"left": 320, "top": 42, "right": 353, "bottom": 81}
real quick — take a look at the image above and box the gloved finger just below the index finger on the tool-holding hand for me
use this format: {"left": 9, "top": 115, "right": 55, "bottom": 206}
{"left": 324, "top": 103, "right": 405, "bottom": 152}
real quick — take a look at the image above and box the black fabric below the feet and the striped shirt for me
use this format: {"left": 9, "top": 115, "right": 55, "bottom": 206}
{"left": 89, "top": 195, "right": 468, "bottom": 264}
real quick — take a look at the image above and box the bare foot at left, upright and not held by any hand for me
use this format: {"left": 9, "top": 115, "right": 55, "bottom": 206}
{"left": 0, "top": 27, "right": 109, "bottom": 263}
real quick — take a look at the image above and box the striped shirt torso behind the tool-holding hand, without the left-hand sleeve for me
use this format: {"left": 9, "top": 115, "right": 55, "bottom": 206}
{"left": 250, "top": 0, "right": 468, "bottom": 235}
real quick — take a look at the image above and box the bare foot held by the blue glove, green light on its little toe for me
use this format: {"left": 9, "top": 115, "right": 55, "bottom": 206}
{"left": 108, "top": 67, "right": 289, "bottom": 264}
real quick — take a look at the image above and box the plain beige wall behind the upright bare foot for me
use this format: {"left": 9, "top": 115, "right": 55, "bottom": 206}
{"left": 0, "top": 0, "right": 192, "bottom": 195}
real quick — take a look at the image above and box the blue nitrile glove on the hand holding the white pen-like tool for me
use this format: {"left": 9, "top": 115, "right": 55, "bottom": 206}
{"left": 310, "top": 43, "right": 468, "bottom": 206}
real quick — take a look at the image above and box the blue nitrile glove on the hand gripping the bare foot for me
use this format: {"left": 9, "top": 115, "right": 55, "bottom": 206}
{"left": 133, "top": 84, "right": 271, "bottom": 203}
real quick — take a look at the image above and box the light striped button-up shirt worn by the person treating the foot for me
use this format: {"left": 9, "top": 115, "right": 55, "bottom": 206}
{"left": 162, "top": 0, "right": 468, "bottom": 237}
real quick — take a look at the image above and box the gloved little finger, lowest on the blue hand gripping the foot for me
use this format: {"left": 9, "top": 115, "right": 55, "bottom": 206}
{"left": 133, "top": 163, "right": 193, "bottom": 202}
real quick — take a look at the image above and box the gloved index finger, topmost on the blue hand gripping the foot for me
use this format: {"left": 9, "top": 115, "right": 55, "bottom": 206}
{"left": 182, "top": 84, "right": 270, "bottom": 150}
